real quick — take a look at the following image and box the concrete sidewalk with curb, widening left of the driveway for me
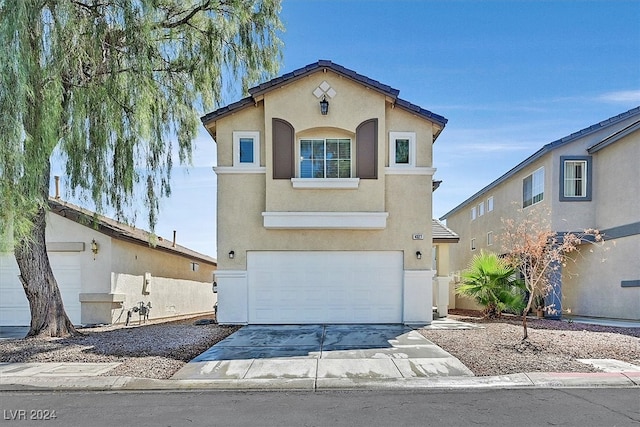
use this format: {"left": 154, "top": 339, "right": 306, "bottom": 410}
{"left": 0, "top": 363, "right": 640, "bottom": 391}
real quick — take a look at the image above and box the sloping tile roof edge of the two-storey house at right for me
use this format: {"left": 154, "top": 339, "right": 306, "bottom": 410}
{"left": 440, "top": 106, "right": 640, "bottom": 219}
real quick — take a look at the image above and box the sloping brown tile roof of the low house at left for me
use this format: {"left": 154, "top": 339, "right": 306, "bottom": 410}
{"left": 49, "top": 197, "right": 218, "bottom": 265}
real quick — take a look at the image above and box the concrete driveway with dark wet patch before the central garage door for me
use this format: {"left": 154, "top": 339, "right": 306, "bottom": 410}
{"left": 172, "top": 325, "right": 473, "bottom": 382}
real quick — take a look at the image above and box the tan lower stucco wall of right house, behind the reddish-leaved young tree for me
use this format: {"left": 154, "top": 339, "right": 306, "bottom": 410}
{"left": 562, "top": 235, "right": 640, "bottom": 321}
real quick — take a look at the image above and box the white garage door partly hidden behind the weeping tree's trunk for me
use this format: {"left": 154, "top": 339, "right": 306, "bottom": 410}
{"left": 0, "top": 253, "right": 81, "bottom": 326}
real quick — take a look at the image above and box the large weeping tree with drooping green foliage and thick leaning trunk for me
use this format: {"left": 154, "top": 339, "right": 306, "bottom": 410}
{"left": 0, "top": 0, "right": 282, "bottom": 337}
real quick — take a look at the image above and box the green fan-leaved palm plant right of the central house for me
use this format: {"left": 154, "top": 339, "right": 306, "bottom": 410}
{"left": 456, "top": 251, "right": 525, "bottom": 318}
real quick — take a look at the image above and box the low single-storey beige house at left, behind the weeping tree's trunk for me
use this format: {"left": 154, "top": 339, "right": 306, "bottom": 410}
{"left": 0, "top": 198, "right": 217, "bottom": 326}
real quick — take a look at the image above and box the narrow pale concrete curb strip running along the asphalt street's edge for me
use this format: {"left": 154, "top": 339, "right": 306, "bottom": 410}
{"left": 0, "top": 372, "right": 640, "bottom": 391}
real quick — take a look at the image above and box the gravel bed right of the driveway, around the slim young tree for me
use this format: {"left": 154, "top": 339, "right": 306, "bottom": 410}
{"left": 420, "top": 310, "right": 640, "bottom": 376}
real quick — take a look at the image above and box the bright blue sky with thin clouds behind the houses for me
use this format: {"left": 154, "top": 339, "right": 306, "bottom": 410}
{"left": 53, "top": 0, "right": 640, "bottom": 256}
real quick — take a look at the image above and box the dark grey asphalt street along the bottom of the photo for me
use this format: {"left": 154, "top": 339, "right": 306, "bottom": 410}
{"left": 0, "top": 388, "right": 640, "bottom": 427}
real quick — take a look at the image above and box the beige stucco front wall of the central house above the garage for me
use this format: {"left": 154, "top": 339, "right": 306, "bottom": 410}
{"left": 215, "top": 71, "right": 434, "bottom": 270}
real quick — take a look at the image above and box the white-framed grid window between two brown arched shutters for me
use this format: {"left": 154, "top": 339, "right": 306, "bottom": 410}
{"left": 300, "top": 138, "right": 351, "bottom": 178}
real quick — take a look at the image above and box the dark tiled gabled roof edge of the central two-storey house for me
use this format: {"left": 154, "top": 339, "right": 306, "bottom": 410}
{"left": 200, "top": 59, "right": 447, "bottom": 127}
